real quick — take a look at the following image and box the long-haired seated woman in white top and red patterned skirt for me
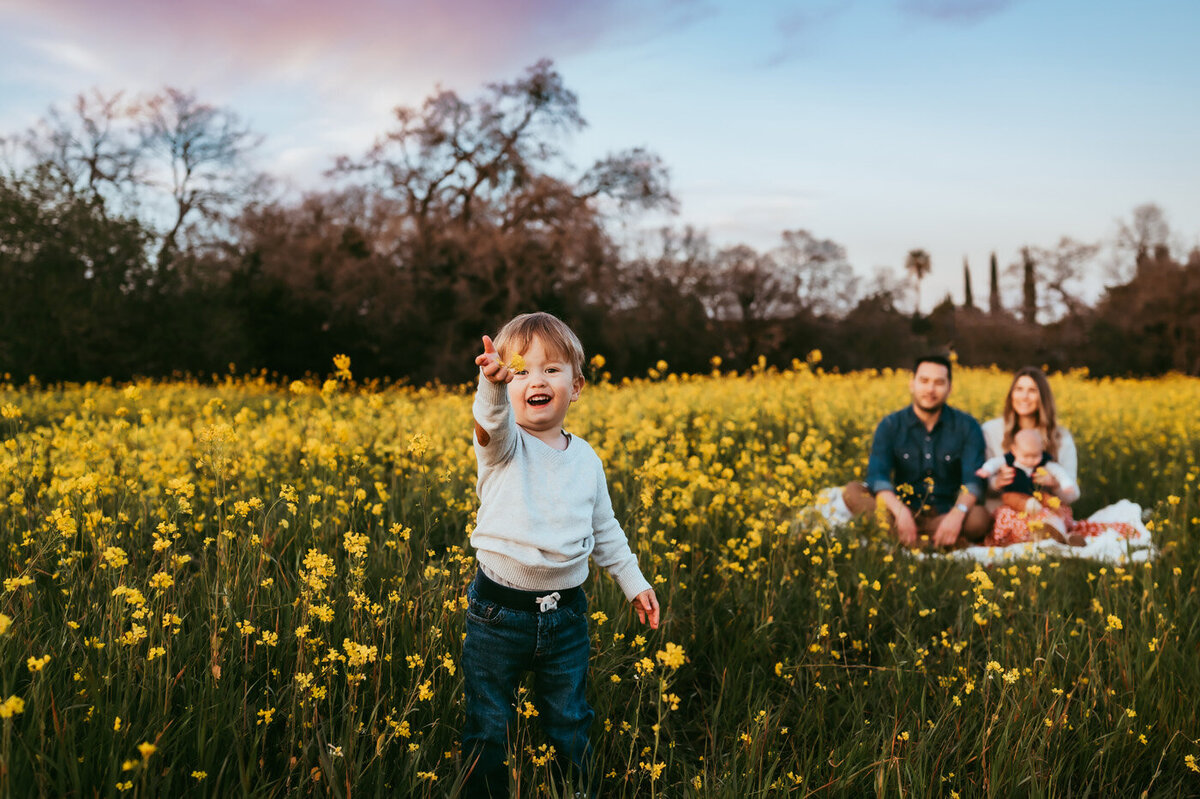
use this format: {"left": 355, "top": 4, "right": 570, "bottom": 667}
{"left": 983, "top": 366, "right": 1079, "bottom": 546}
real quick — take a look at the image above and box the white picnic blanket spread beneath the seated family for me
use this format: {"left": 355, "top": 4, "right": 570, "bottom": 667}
{"left": 812, "top": 487, "right": 1158, "bottom": 564}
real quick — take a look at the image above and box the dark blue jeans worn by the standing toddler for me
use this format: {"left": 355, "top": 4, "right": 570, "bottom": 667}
{"left": 462, "top": 575, "right": 594, "bottom": 797}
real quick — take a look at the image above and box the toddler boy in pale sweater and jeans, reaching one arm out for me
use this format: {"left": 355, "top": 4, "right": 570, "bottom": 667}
{"left": 462, "top": 313, "right": 659, "bottom": 797}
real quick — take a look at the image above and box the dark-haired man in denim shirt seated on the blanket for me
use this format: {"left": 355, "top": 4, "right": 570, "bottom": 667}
{"left": 842, "top": 355, "right": 991, "bottom": 547}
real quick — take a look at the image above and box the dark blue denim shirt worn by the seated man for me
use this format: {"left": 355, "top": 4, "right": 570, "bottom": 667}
{"left": 866, "top": 405, "right": 984, "bottom": 515}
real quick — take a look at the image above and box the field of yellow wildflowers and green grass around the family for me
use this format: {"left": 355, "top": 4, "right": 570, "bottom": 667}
{"left": 0, "top": 359, "right": 1200, "bottom": 798}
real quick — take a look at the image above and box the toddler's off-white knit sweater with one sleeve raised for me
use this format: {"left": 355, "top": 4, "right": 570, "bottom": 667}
{"left": 470, "top": 376, "right": 650, "bottom": 599}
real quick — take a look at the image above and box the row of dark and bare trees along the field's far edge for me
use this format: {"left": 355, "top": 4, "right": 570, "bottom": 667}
{"left": 0, "top": 61, "right": 1200, "bottom": 383}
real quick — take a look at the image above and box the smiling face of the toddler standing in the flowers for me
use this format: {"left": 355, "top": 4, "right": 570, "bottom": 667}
{"left": 509, "top": 328, "right": 583, "bottom": 445}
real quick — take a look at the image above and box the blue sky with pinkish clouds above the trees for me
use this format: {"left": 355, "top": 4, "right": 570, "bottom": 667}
{"left": 0, "top": 0, "right": 1200, "bottom": 310}
